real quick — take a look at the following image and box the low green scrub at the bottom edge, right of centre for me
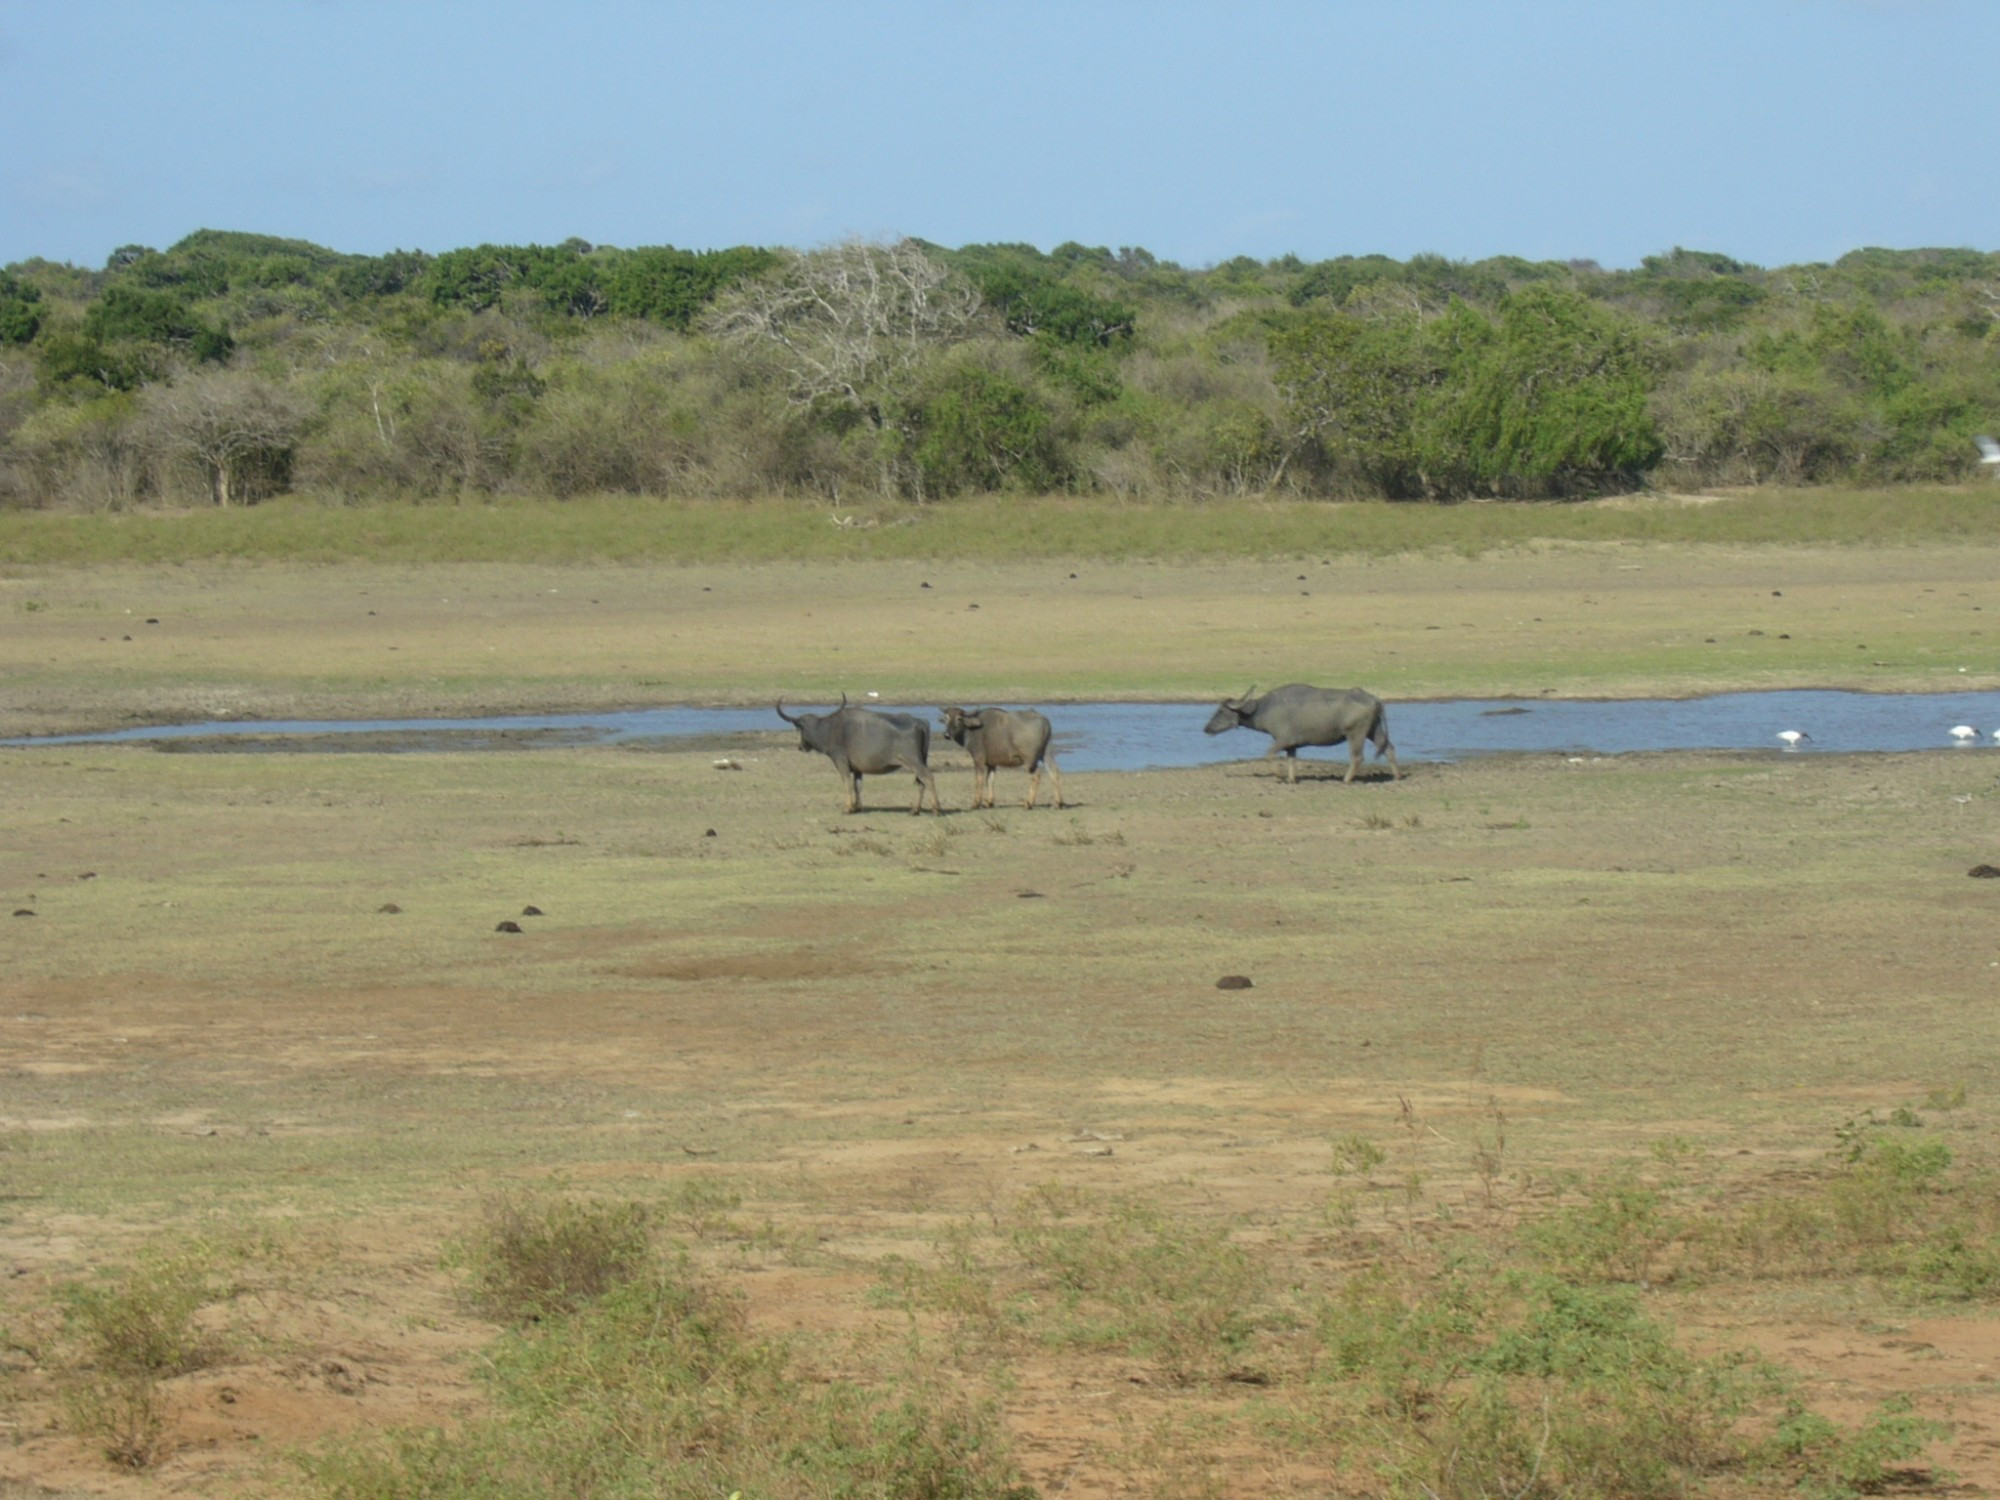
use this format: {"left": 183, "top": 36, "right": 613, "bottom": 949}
{"left": 1278, "top": 1260, "right": 1946, "bottom": 1500}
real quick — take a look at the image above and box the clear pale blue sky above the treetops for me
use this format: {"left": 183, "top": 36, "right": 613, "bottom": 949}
{"left": 0, "top": 0, "right": 2000, "bottom": 266}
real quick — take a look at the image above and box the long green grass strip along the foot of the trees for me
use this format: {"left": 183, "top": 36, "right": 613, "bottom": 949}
{"left": 0, "top": 486, "right": 1994, "bottom": 564}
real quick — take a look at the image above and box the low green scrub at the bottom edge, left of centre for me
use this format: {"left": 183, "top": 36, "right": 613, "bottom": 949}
{"left": 302, "top": 1260, "right": 1032, "bottom": 1500}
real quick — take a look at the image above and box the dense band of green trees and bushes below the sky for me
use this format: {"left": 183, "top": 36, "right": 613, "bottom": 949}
{"left": 0, "top": 230, "right": 2000, "bottom": 508}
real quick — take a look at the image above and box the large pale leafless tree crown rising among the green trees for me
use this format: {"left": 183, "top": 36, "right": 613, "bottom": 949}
{"left": 708, "top": 240, "right": 980, "bottom": 426}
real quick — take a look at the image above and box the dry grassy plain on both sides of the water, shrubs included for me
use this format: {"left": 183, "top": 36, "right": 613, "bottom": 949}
{"left": 0, "top": 494, "right": 2000, "bottom": 1500}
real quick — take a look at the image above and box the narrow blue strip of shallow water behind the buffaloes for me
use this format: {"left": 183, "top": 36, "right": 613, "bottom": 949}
{"left": 11, "top": 690, "right": 2000, "bottom": 770}
